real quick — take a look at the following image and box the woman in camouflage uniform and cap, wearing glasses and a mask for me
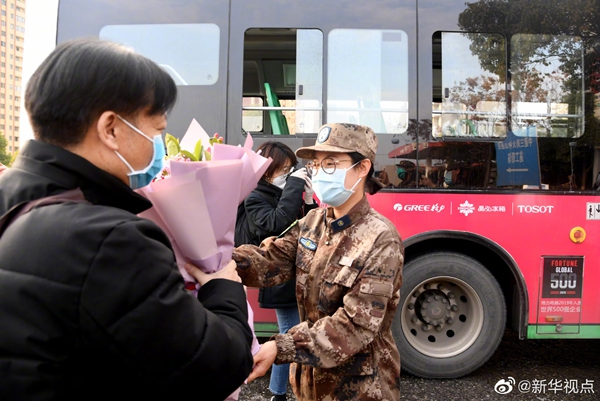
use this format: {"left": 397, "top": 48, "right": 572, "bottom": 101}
{"left": 189, "top": 124, "right": 404, "bottom": 401}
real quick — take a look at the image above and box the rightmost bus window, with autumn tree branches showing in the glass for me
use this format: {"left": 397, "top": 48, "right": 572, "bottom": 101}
{"left": 510, "top": 34, "right": 584, "bottom": 138}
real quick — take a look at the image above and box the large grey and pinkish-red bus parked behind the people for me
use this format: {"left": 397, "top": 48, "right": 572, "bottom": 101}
{"left": 56, "top": 0, "right": 600, "bottom": 378}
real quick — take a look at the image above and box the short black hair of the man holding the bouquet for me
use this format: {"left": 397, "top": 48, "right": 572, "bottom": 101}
{"left": 25, "top": 38, "right": 177, "bottom": 147}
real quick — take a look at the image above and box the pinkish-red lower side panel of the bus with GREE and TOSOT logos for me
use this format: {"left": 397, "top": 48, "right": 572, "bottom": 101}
{"left": 369, "top": 192, "right": 600, "bottom": 332}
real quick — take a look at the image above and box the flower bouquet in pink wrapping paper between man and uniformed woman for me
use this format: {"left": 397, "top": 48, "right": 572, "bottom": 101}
{"left": 138, "top": 120, "right": 272, "bottom": 400}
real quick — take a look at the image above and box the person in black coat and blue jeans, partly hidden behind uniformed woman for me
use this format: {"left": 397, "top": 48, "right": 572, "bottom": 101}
{"left": 235, "top": 141, "right": 317, "bottom": 401}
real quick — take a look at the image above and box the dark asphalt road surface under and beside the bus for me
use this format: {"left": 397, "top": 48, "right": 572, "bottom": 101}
{"left": 239, "top": 331, "right": 600, "bottom": 401}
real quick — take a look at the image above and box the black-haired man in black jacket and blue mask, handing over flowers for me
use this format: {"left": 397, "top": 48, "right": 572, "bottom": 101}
{"left": 0, "top": 40, "right": 252, "bottom": 401}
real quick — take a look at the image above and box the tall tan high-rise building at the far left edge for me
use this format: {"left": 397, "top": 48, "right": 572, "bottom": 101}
{"left": 0, "top": 0, "right": 25, "bottom": 154}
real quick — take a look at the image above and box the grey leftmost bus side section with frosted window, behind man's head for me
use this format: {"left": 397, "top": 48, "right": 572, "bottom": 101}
{"left": 57, "top": 0, "right": 229, "bottom": 138}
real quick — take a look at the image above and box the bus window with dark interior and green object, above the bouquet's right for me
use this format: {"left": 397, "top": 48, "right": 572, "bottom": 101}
{"left": 242, "top": 28, "right": 323, "bottom": 135}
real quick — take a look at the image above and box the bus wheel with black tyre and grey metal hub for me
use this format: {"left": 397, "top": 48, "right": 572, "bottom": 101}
{"left": 392, "top": 252, "right": 506, "bottom": 379}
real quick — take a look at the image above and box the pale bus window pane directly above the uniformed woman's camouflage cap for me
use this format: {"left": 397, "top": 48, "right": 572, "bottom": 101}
{"left": 327, "top": 29, "right": 408, "bottom": 134}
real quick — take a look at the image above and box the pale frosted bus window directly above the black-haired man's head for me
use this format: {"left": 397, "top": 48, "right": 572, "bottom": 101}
{"left": 99, "top": 24, "right": 220, "bottom": 86}
